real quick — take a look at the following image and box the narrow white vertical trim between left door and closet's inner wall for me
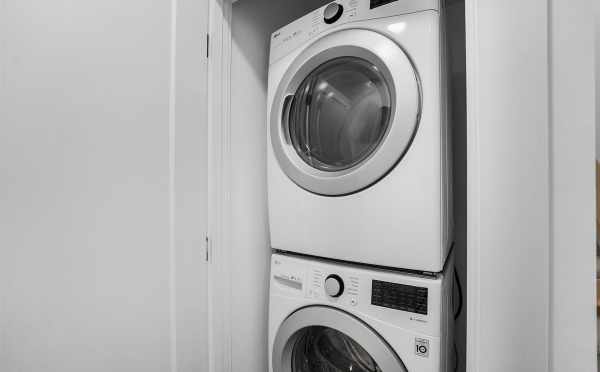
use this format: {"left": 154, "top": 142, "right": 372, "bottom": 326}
{"left": 207, "top": 0, "right": 232, "bottom": 372}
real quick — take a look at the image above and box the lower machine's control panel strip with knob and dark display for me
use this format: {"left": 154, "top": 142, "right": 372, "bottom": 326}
{"left": 269, "top": 252, "right": 452, "bottom": 336}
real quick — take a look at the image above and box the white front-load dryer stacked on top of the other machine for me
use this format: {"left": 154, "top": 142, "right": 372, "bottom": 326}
{"left": 267, "top": 0, "right": 453, "bottom": 272}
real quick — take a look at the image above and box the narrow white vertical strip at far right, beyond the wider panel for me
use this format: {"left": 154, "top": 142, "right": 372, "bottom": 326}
{"left": 550, "top": 0, "right": 597, "bottom": 372}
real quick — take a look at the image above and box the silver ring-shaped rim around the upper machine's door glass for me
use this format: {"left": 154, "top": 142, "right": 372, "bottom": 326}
{"left": 270, "top": 29, "right": 422, "bottom": 196}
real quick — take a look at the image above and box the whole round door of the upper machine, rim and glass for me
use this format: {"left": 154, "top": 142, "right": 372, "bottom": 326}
{"left": 270, "top": 29, "right": 421, "bottom": 196}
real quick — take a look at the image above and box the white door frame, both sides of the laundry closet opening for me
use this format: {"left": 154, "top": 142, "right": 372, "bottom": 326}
{"left": 209, "top": 0, "right": 596, "bottom": 372}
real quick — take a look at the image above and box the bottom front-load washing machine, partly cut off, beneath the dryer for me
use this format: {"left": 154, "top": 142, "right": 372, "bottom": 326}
{"left": 269, "top": 254, "right": 455, "bottom": 372}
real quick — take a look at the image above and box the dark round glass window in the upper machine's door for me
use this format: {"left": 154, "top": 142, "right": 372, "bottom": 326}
{"left": 289, "top": 57, "right": 391, "bottom": 172}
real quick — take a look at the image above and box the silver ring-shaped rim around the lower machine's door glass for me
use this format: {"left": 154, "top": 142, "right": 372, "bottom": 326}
{"left": 272, "top": 306, "right": 407, "bottom": 372}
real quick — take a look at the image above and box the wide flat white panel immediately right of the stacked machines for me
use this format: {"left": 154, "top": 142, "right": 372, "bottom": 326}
{"left": 466, "top": 0, "right": 550, "bottom": 372}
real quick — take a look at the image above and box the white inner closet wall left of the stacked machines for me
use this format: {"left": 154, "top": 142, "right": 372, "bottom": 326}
{"left": 231, "top": 0, "right": 326, "bottom": 372}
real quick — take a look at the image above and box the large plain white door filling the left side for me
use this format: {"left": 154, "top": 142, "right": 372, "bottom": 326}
{"left": 0, "top": 0, "right": 207, "bottom": 372}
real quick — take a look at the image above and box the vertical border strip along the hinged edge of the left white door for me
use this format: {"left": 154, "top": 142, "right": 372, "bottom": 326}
{"left": 172, "top": 0, "right": 209, "bottom": 372}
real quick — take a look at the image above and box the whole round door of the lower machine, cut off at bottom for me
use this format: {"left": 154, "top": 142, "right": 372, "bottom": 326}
{"left": 272, "top": 306, "right": 407, "bottom": 372}
